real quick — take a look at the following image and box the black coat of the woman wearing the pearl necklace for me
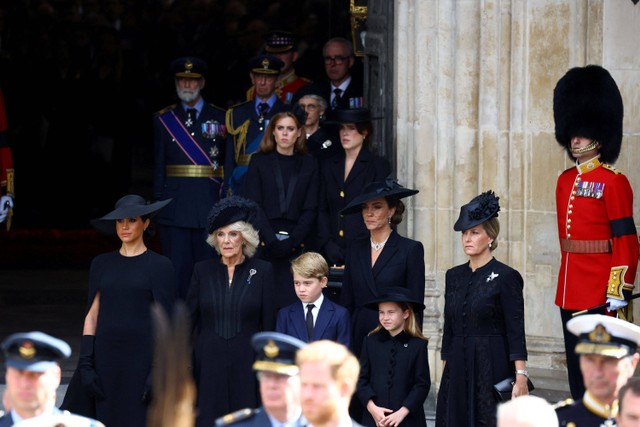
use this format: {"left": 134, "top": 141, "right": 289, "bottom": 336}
{"left": 340, "top": 231, "right": 425, "bottom": 355}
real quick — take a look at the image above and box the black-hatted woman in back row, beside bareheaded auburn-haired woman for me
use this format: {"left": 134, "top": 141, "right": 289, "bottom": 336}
{"left": 318, "top": 108, "right": 391, "bottom": 265}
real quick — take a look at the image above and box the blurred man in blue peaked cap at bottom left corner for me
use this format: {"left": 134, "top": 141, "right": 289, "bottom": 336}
{"left": 0, "top": 332, "right": 102, "bottom": 427}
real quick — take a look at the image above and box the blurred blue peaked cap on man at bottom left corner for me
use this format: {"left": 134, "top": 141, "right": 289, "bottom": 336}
{"left": 2, "top": 331, "right": 71, "bottom": 372}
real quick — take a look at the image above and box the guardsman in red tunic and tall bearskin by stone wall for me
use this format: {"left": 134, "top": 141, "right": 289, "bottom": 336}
{"left": 553, "top": 65, "right": 638, "bottom": 400}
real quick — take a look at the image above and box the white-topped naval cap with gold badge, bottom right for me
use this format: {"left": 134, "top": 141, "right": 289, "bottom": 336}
{"left": 567, "top": 314, "right": 640, "bottom": 359}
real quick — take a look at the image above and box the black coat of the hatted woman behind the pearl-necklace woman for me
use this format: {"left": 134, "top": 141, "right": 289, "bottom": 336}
{"left": 318, "top": 147, "right": 391, "bottom": 265}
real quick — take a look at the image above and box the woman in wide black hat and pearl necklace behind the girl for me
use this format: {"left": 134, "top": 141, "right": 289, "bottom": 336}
{"left": 340, "top": 178, "right": 424, "bottom": 355}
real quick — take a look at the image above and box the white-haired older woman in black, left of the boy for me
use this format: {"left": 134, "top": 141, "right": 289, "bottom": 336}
{"left": 187, "top": 196, "right": 276, "bottom": 427}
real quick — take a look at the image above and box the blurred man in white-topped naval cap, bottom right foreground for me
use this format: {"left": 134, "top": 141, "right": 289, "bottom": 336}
{"left": 556, "top": 314, "right": 640, "bottom": 427}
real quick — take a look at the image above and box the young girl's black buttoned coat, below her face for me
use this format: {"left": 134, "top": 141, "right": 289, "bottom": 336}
{"left": 357, "top": 332, "right": 431, "bottom": 427}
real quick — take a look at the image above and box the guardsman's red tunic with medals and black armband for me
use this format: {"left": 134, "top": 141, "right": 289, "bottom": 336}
{"left": 555, "top": 158, "right": 638, "bottom": 310}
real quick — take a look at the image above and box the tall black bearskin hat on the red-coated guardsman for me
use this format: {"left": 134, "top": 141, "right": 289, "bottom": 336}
{"left": 553, "top": 65, "right": 624, "bottom": 163}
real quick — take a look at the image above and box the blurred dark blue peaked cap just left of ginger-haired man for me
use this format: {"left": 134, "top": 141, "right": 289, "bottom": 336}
{"left": 251, "top": 332, "right": 305, "bottom": 376}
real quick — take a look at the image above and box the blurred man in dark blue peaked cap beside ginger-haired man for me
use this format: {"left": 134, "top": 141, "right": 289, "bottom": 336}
{"left": 216, "top": 332, "right": 307, "bottom": 427}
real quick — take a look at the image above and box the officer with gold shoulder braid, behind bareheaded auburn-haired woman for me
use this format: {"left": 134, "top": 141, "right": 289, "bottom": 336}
{"left": 225, "top": 55, "right": 289, "bottom": 196}
